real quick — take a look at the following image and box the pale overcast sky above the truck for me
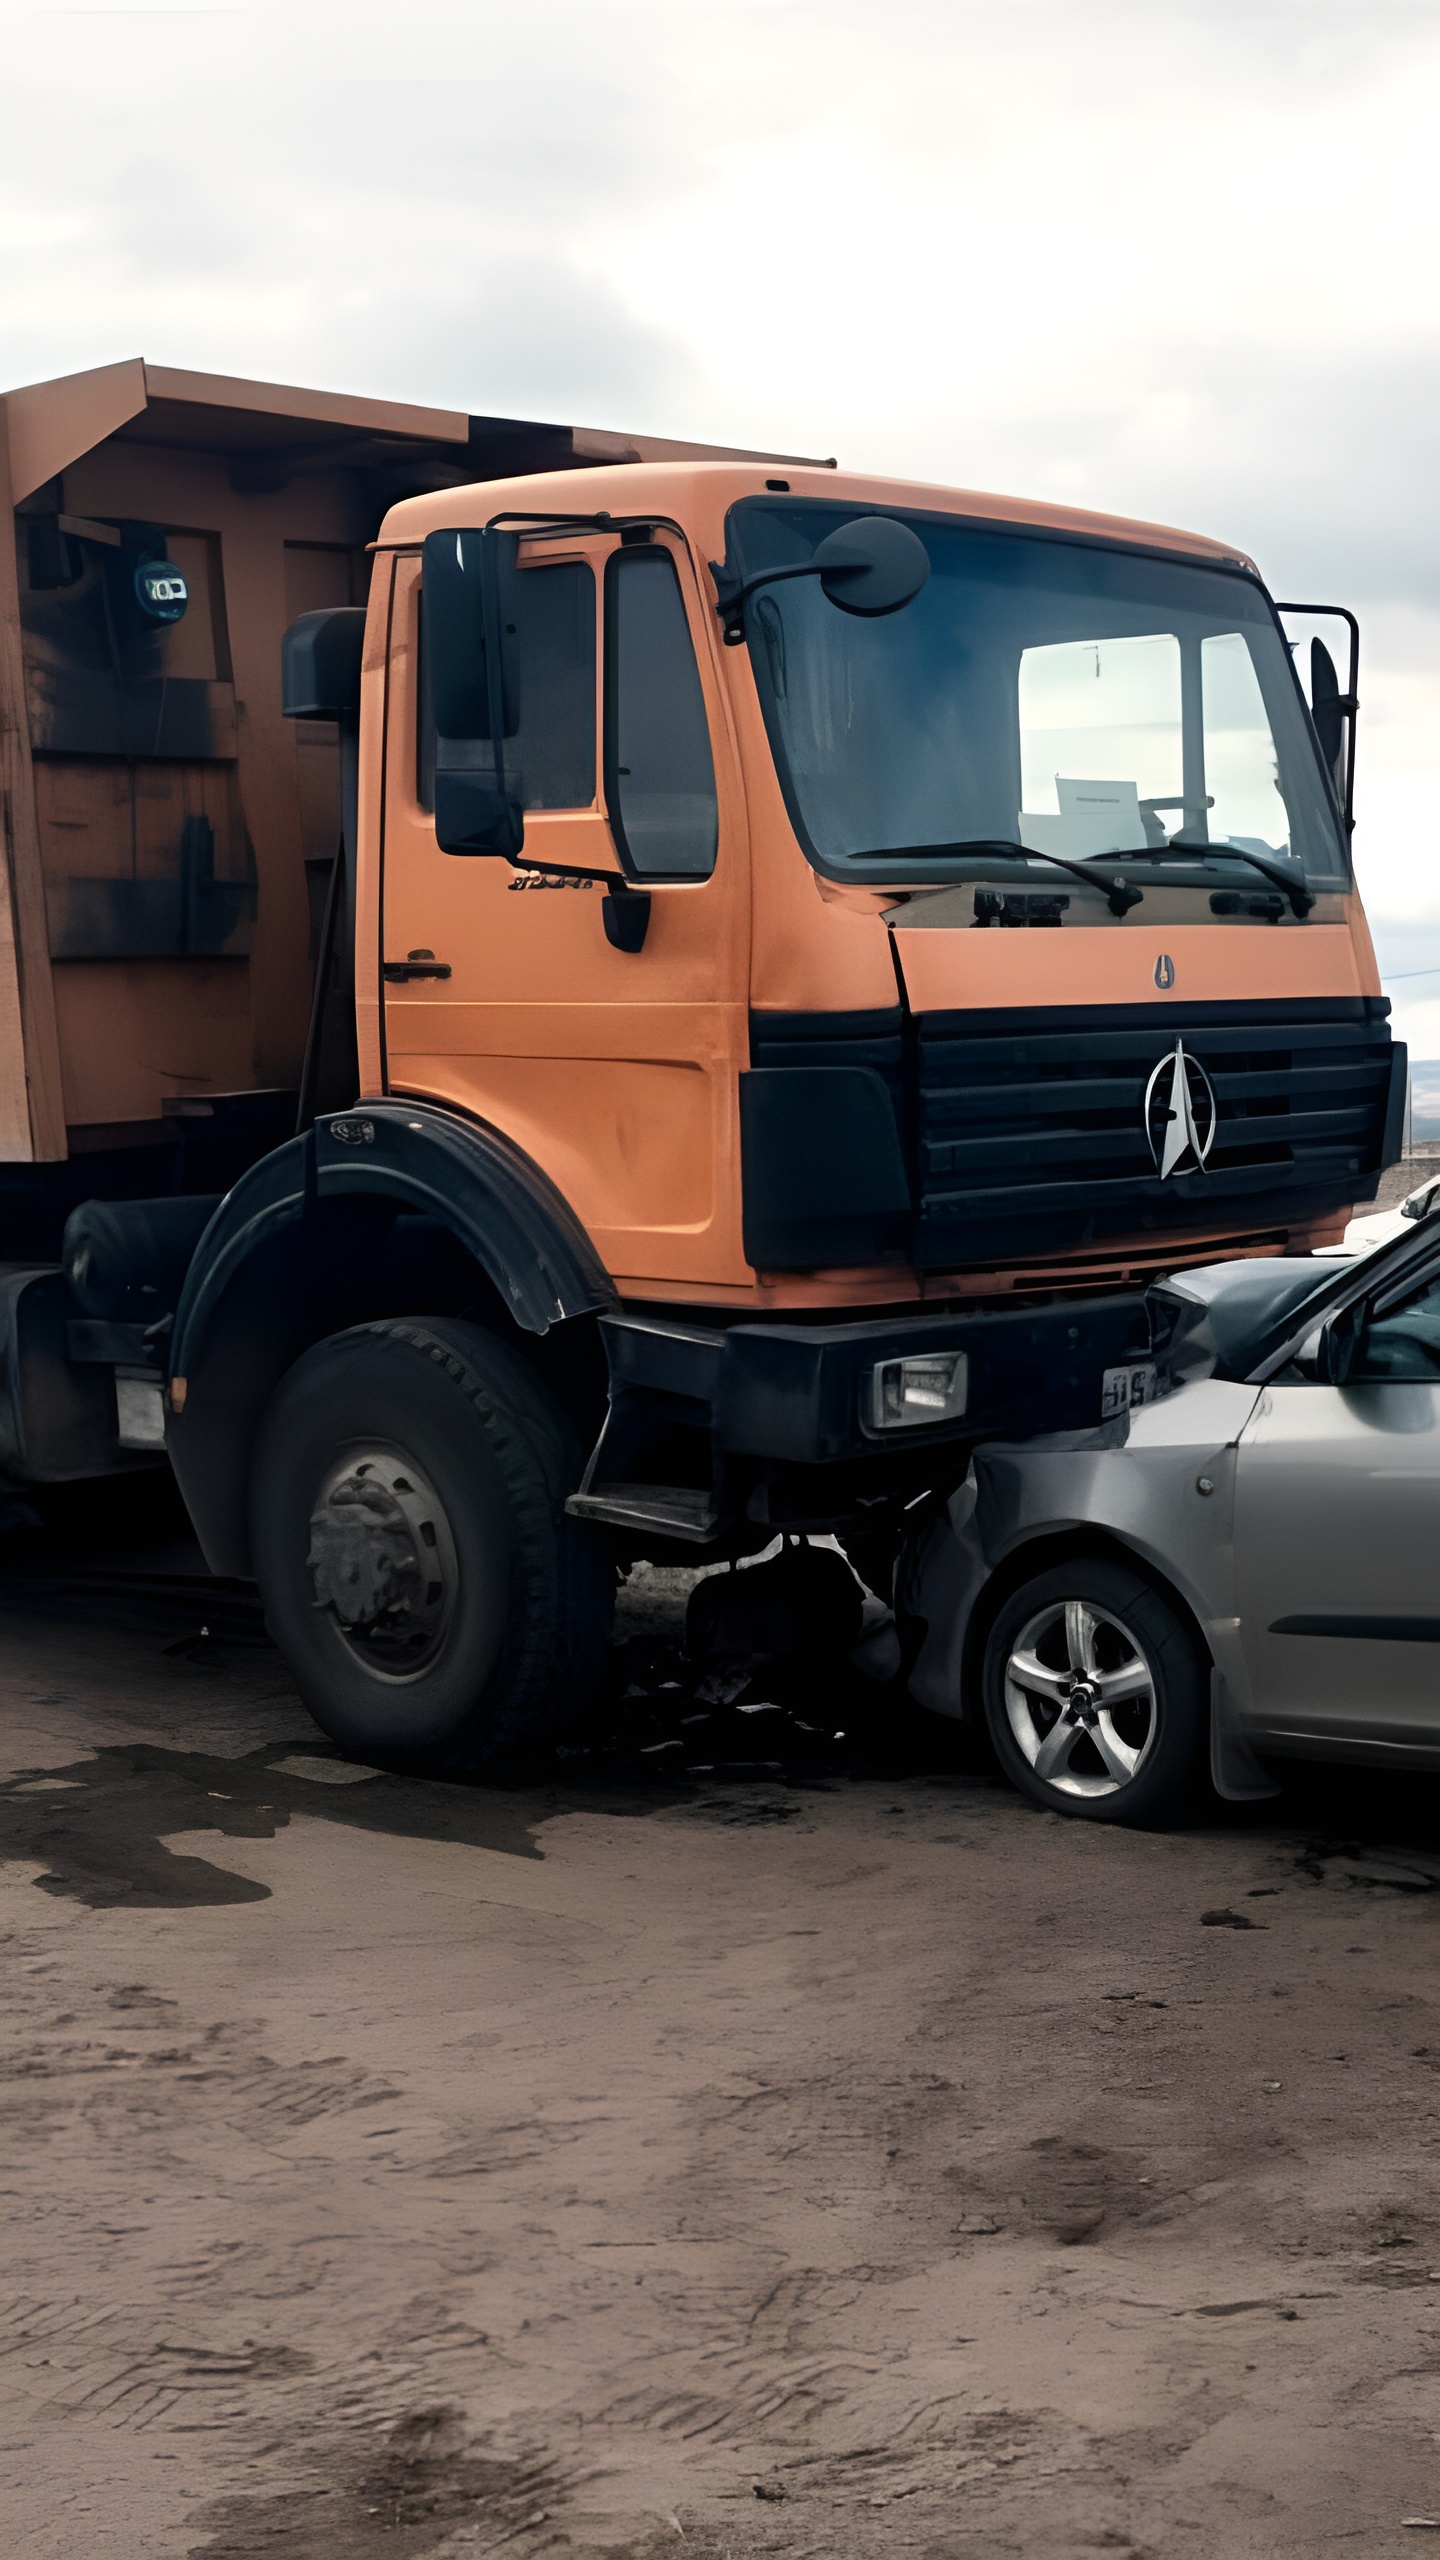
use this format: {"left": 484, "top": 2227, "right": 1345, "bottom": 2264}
{"left": 0, "top": 0, "right": 1440, "bottom": 1057}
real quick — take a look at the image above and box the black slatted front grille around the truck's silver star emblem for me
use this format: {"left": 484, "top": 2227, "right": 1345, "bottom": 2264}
{"left": 912, "top": 998, "right": 1391, "bottom": 1270}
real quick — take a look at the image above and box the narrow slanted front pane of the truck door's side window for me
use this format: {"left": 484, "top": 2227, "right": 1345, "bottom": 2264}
{"left": 605, "top": 545, "right": 720, "bottom": 881}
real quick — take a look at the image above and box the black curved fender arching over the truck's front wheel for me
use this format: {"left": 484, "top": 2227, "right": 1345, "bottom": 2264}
{"left": 167, "top": 1101, "right": 618, "bottom": 1574}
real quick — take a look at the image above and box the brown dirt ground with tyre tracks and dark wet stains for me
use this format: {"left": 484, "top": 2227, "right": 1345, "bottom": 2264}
{"left": 0, "top": 1505, "right": 1440, "bottom": 2560}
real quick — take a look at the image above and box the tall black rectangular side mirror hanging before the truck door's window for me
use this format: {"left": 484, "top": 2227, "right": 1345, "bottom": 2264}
{"left": 420, "top": 525, "right": 525, "bottom": 860}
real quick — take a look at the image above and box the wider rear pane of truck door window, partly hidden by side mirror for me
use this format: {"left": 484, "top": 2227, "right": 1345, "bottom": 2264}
{"left": 415, "top": 561, "right": 594, "bottom": 809}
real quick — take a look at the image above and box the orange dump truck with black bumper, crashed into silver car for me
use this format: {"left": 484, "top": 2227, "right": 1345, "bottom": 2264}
{"left": 0, "top": 364, "right": 1404, "bottom": 1769}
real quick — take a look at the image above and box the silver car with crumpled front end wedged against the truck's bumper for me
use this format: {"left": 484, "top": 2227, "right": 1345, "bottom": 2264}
{"left": 897, "top": 1221, "right": 1440, "bottom": 1823}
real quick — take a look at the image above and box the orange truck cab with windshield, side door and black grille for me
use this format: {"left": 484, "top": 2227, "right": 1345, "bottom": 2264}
{"left": 359, "top": 463, "right": 1394, "bottom": 1311}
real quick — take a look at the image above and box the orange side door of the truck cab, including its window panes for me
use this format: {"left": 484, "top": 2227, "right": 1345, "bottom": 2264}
{"left": 382, "top": 532, "right": 748, "bottom": 1295}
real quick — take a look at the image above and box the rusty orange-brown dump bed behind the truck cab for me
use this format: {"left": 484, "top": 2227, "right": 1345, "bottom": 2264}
{"left": 0, "top": 358, "right": 809, "bottom": 1257}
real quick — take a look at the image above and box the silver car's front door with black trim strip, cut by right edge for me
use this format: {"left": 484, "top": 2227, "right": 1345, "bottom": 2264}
{"left": 1235, "top": 1252, "right": 1440, "bottom": 1748}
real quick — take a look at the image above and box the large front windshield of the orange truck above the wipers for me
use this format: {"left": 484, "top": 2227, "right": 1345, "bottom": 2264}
{"left": 728, "top": 499, "right": 1348, "bottom": 888}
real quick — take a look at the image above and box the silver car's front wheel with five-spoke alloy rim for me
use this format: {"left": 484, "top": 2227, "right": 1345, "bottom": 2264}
{"left": 981, "top": 1556, "right": 1209, "bottom": 1825}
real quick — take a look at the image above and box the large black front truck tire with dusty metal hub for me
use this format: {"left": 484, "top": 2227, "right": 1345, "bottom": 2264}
{"left": 251, "top": 1318, "right": 615, "bottom": 1777}
